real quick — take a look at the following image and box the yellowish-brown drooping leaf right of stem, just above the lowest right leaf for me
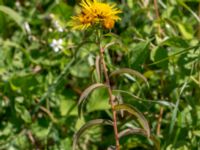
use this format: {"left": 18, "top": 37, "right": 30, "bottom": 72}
{"left": 114, "top": 104, "right": 150, "bottom": 137}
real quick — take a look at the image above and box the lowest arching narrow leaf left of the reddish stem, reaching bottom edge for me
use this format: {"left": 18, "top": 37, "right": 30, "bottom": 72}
{"left": 72, "top": 119, "right": 113, "bottom": 150}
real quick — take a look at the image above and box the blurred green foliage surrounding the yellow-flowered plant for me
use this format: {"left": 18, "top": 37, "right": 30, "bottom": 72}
{"left": 0, "top": 0, "right": 200, "bottom": 150}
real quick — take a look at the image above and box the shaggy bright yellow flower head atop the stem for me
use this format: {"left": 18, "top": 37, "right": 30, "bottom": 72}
{"left": 71, "top": 0, "right": 121, "bottom": 30}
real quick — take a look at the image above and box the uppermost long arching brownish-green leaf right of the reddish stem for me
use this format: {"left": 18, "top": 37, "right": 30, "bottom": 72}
{"left": 110, "top": 68, "right": 149, "bottom": 86}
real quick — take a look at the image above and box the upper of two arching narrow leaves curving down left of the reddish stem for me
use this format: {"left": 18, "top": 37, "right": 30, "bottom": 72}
{"left": 78, "top": 83, "right": 107, "bottom": 116}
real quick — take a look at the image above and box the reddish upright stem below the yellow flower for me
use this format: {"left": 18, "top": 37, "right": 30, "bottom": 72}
{"left": 99, "top": 44, "right": 120, "bottom": 150}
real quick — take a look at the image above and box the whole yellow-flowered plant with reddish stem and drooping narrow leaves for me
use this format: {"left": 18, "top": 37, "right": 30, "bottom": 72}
{"left": 70, "top": 0, "right": 159, "bottom": 150}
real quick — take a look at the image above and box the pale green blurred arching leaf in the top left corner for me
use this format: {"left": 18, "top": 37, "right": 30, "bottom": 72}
{"left": 0, "top": 5, "right": 24, "bottom": 31}
